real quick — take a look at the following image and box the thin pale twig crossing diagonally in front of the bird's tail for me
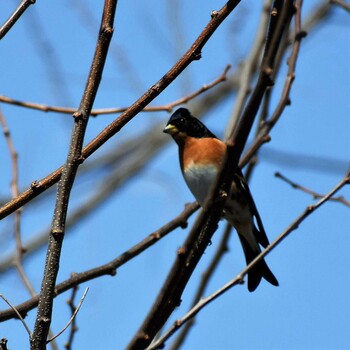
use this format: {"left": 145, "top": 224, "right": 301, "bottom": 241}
{"left": 147, "top": 171, "right": 350, "bottom": 350}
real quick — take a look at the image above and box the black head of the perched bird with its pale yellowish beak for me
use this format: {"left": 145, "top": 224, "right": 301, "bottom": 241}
{"left": 163, "top": 108, "right": 216, "bottom": 138}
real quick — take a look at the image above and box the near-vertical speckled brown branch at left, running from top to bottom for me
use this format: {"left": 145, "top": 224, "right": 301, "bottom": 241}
{"left": 31, "top": 0, "right": 117, "bottom": 349}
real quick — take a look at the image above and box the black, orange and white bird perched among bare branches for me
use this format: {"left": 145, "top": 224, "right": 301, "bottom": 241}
{"left": 163, "top": 108, "right": 278, "bottom": 292}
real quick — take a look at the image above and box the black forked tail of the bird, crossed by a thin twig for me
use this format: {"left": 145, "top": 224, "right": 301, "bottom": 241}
{"left": 238, "top": 235, "right": 278, "bottom": 292}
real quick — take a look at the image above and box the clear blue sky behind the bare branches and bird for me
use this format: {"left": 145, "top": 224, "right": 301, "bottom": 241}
{"left": 0, "top": 0, "right": 350, "bottom": 350}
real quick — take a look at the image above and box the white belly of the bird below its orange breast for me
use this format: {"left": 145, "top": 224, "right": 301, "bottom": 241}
{"left": 184, "top": 164, "right": 218, "bottom": 206}
